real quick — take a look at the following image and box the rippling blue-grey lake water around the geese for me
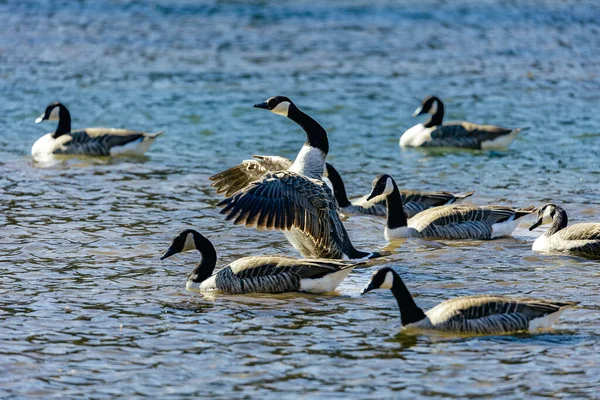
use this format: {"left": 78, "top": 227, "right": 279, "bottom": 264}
{"left": 0, "top": 0, "right": 600, "bottom": 399}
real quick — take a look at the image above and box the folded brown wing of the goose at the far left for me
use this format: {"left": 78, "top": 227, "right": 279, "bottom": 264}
{"left": 55, "top": 128, "right": 146, "bottom": 156}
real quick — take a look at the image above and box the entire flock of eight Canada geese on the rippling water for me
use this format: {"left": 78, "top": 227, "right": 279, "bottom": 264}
{"left": 32, "top": 96, "right": 600, "bottom": 334}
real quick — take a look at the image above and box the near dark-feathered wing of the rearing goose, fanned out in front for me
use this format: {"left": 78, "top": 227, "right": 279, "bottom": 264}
{"left": 218, "top": 171, "right": 347, "bottom": 252}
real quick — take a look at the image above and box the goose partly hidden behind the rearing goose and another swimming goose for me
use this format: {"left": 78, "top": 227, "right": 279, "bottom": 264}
{"left": 325, "top": 163, "right": 475, "bottom": 218}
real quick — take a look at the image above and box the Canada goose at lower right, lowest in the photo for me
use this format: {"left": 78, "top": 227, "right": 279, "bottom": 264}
{"left": 362, "top": 267, "right": 578, "bottom": 334}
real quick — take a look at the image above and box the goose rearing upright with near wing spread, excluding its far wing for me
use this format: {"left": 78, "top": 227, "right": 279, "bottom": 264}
{"left": 218, "top": 96, "right": 387, "bottom": 259}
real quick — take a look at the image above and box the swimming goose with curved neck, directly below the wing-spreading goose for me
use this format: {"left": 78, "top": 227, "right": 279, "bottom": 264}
{"left": 160, "top": 229, "right": 364, "bottom": 294}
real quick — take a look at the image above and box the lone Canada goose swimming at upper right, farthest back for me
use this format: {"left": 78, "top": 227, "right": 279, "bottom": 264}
{"left": 400, "top": 96, "right": 526, "bottom": 150}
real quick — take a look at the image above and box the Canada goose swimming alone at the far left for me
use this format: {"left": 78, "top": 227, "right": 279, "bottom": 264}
{"left": 31, "top": 102, "right": 162, "bottom": 157}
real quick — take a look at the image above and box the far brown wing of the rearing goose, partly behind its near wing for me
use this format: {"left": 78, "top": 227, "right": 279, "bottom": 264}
{"left": 208, "top": 156, "right": 292, "bottom": 197}
